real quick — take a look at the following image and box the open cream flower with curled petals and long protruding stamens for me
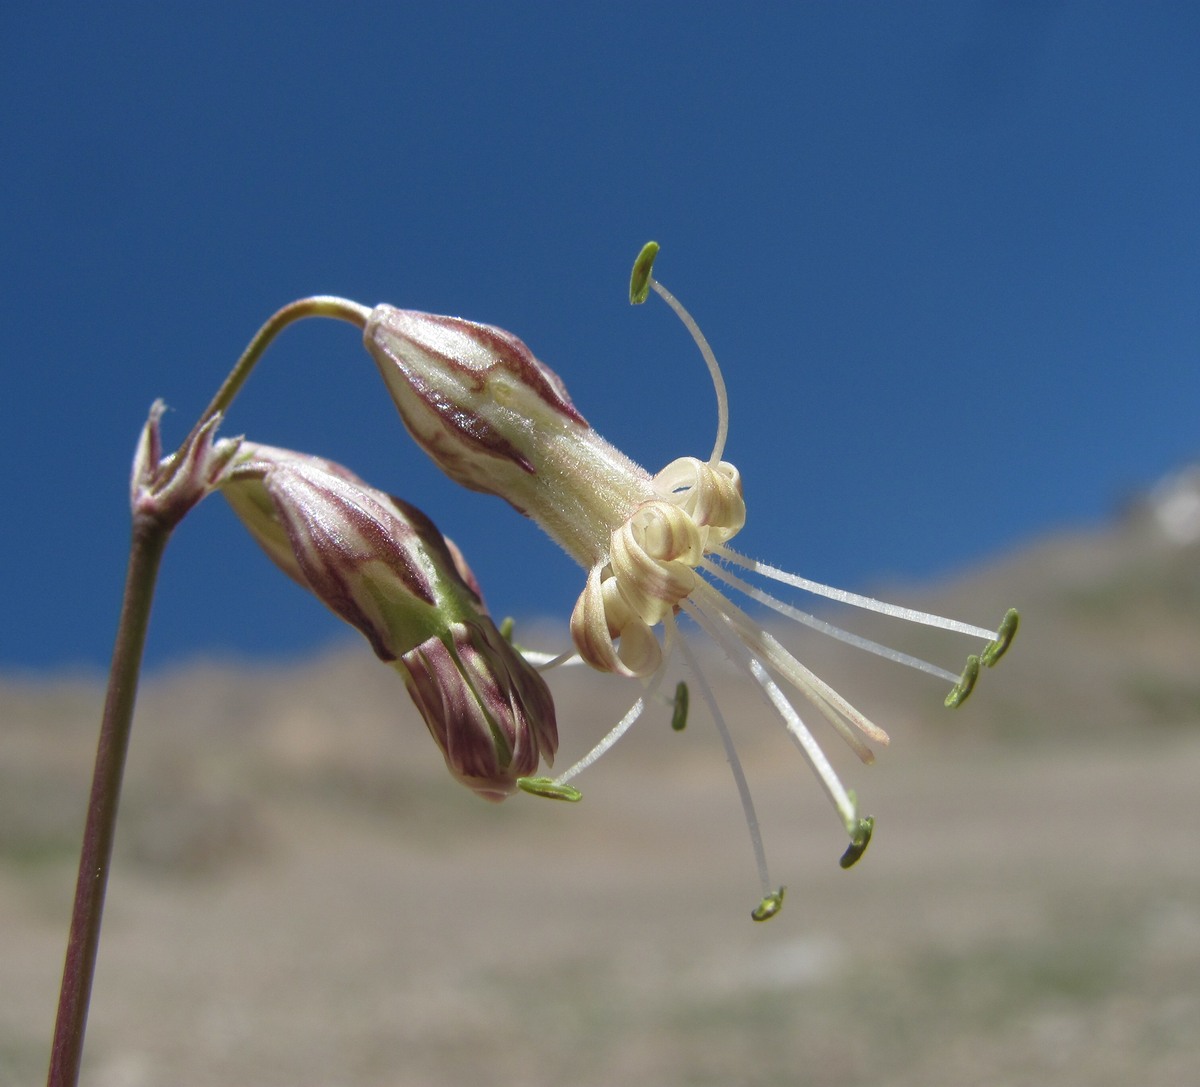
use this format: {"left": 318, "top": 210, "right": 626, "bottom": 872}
{"left": 364, "top": 242, "right": 1016, "bottom": 919}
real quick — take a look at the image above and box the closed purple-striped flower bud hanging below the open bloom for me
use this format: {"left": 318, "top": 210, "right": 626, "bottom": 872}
{"left": 221, "top": 442, "right": 558, "bottom": 800}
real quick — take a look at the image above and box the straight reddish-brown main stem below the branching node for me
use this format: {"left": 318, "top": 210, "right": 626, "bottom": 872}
{"left": 47, "top": 517, "right": 170, "bottom": 1087}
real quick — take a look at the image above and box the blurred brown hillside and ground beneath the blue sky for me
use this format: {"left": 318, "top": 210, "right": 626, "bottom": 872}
{"left": 0, "top": 513, "right": 1200, "bottom": 1087}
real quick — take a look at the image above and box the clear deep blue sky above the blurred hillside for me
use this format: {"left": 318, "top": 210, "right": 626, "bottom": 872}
{"left": 0, "top": 0, "right": 1200, "bottom": 669}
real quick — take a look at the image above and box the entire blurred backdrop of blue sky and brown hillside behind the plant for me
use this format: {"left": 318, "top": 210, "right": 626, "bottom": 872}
{"left": 0, "top": 2, "right": 1200, "bottom": 1085}
